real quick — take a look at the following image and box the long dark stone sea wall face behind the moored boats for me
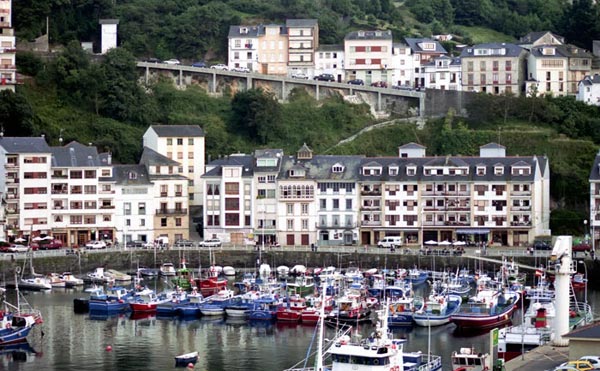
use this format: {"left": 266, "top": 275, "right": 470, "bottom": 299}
{"left": 0, "top": 249, "right": 600, "bottom": 285}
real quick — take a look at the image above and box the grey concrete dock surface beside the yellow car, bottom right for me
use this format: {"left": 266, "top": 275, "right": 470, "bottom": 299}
{"left": 505, "top": 345, "right": 569, "bottom": 371}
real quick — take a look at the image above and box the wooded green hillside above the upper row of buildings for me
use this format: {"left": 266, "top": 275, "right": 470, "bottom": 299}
{"left": 13, "top": 0, "right": 600, "bottom": 61}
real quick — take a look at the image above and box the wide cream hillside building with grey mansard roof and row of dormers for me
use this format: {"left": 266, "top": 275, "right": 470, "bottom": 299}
{"left": 460, "top": 43, "right": 527, "bottom": 96}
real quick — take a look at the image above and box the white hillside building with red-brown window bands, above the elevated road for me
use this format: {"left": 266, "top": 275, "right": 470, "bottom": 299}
{"left": 344, "top": 31, "right": 393, "bottom": 85}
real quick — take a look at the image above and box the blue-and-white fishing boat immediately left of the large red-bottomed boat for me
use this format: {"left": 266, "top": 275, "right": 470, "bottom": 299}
{"left": 413, "top": 293, "right": 462, "bottom": 326}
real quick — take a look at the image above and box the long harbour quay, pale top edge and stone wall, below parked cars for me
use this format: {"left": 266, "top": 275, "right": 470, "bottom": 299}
{"left": 0, "top": 246, "right": 600, "bottom": 284}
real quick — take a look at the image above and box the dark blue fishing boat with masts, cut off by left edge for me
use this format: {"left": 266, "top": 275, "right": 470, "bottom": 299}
{"left": 0, "top": 280, "right": 43, "bottom": 346}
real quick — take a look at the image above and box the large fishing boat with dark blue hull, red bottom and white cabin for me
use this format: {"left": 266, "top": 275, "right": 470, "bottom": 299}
{"left": 450, "top": 289, "right": 519, "bottom": 331}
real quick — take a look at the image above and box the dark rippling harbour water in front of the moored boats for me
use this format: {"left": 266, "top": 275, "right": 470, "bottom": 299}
{"left": 0, "top": 278, "right": 600, "bottom": 371}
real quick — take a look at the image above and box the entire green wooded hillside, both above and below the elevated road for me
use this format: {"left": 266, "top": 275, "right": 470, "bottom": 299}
{"left": 0, "top": 0, "right": 600, "bottom": 233}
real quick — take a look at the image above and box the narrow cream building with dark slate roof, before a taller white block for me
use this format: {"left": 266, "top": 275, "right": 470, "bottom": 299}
{"left": 139, "top": 147, "right": 191, "bottom": 243}
